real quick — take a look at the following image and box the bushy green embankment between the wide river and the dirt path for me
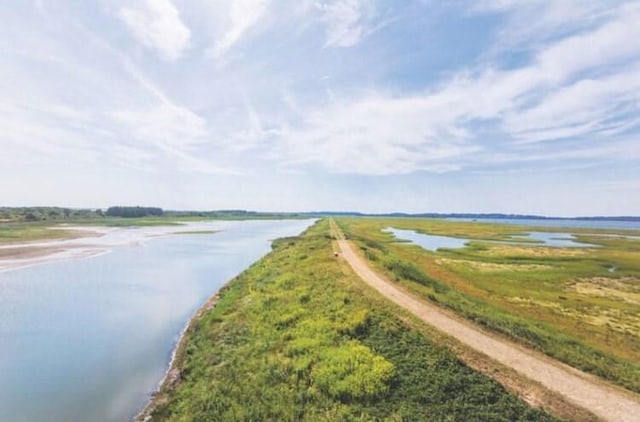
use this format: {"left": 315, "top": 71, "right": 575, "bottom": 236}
{"left": 148, "top": 220, "right": 551, "bottom": 421}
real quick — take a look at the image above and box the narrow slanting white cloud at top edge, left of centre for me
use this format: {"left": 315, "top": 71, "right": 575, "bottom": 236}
{"left": 211, "top": 0, "right": 268, "bottom": 57}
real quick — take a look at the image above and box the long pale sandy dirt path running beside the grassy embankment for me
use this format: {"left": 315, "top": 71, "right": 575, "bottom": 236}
{"left": 338, "top": 224, "right": 640, "bottom": 422}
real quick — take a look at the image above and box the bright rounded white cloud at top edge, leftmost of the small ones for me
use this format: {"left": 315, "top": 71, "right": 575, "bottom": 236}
{"left": 120, "top": 0, "right": 191, "bottom": 60}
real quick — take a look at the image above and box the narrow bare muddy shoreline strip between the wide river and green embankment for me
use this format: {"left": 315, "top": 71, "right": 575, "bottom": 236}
{"left": 131, "top": 292, "right": 225, "bottom": 422}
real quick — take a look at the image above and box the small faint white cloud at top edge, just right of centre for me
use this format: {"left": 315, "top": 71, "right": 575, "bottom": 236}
{"left": 316, "top": 0, "right": 376, "bottom": 47}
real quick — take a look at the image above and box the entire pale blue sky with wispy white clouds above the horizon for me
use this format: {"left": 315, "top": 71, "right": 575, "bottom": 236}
{"left": 0, "top": 0, "right": 640, "bottom": 216}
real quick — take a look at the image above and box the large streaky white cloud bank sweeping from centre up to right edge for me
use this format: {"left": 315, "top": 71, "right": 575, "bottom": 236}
{"left": 239, "top": 0, "right": 640, "bottom": 174}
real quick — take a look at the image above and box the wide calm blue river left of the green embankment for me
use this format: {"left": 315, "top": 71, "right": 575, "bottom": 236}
{"left": 0, "top": 220, "right": 310, "bottom": 422}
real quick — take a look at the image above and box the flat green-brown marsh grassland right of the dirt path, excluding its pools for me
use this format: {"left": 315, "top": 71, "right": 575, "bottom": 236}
{"left": 338, "top": 219, "right": 640, "bottom": 392}
